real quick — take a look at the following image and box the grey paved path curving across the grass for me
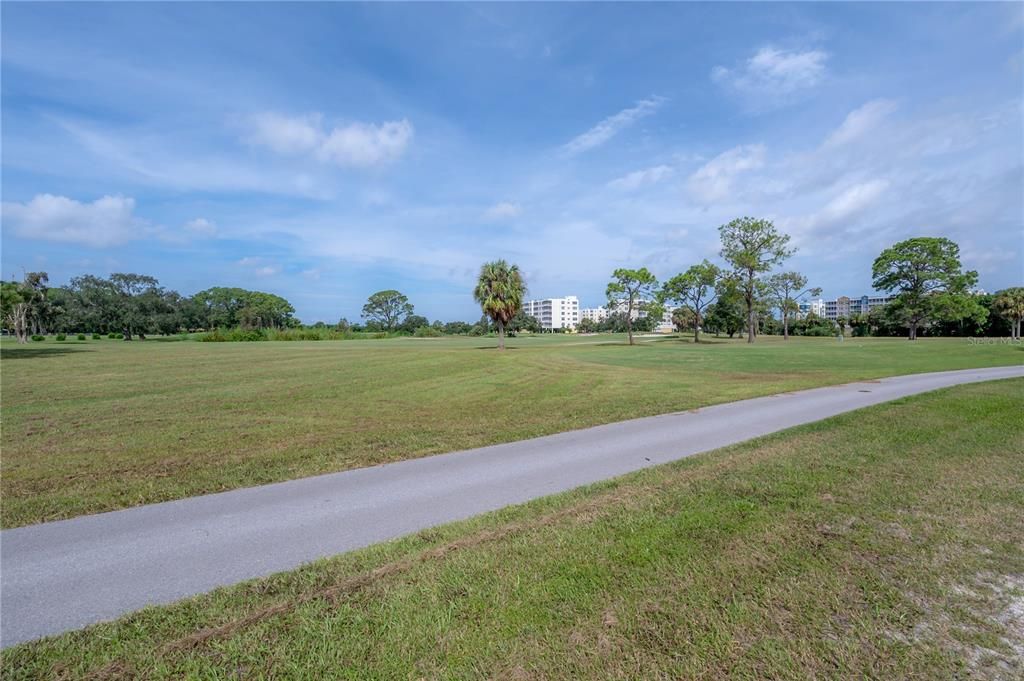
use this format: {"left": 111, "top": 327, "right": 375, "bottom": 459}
{"left": 0, "top": 367, "right": 1024, "bottom": 646}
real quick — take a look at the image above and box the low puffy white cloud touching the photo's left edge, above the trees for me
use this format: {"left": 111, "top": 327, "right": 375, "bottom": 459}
{"left": 3, "top": 194, "right": 152, "bottom": 248}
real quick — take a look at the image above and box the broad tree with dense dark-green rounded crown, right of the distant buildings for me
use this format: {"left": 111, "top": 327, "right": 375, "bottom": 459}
{"left": 871, "top": 237, "right": 981, "bottom": 340}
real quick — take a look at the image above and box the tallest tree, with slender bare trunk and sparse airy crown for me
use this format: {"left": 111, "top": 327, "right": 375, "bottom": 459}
{"left": 718, "top": 217, "right": 794, "bottom": 343}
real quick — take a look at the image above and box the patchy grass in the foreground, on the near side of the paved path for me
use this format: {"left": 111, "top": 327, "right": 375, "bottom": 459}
{"left": 3, "top": 380, "right": 1024, "bottom": 679}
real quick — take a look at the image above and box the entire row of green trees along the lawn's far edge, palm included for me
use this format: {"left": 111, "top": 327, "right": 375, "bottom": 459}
{"left": 0, "top": 217, "right": 1024, "bottom": 348}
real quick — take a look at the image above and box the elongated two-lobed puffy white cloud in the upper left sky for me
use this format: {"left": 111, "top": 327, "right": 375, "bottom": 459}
{"left": 249, "top": 112, "right": 414, "bottom": 168}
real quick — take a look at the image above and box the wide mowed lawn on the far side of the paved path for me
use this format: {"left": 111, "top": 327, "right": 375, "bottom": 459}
{"left": 0, "top": 336, "right": 1024, "bottom": 527}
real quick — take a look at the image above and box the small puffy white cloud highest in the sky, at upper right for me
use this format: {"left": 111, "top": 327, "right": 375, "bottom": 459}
{"left": 711, "top": 46, "right": 828, "bottom": 97}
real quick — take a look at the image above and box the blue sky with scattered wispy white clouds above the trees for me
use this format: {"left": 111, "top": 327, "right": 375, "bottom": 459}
{"left": 0, "top": 2, "right": 1024, "bottom": 323}
